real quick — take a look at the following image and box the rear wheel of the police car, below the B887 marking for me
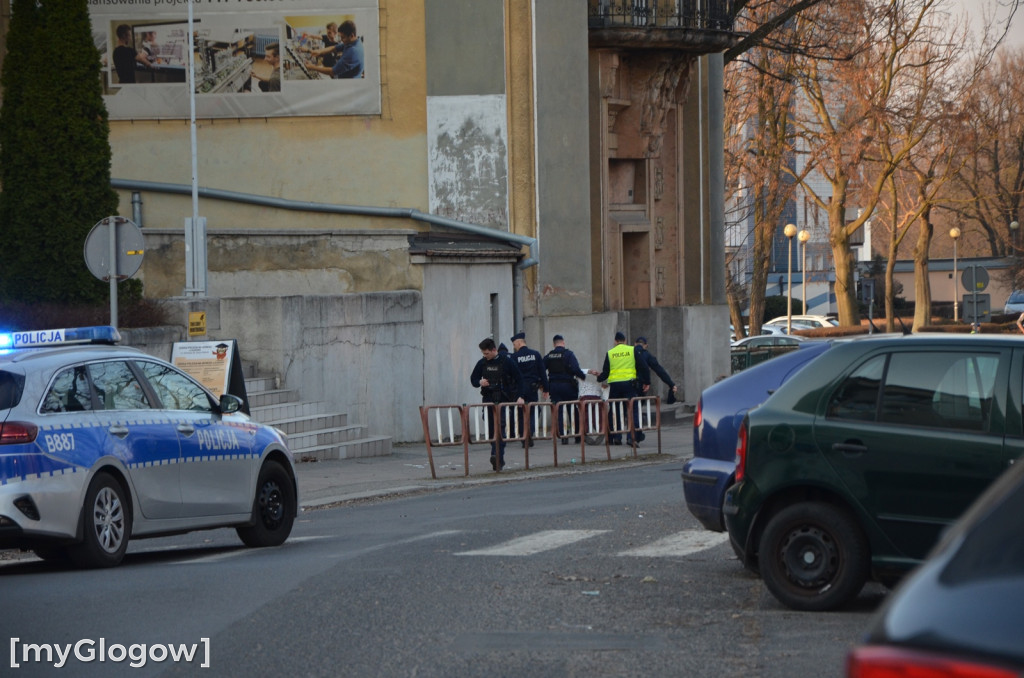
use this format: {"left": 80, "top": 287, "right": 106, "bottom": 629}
{"left": 68, "top": 473, "right": 131, "bottom": 567}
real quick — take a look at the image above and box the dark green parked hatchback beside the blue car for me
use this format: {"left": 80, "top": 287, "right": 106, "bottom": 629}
{"left": 724, "top": 335, "right": 1024, "bottom": 610}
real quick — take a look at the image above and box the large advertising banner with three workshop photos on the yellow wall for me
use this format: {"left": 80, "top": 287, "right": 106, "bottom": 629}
{"left": 89, "top": 0, "right": 381, "bottom": 120}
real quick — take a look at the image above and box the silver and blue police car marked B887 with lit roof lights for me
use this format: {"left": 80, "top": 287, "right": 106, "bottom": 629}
{"left": 0, "top": 327, "right": 298, "bottom": 567}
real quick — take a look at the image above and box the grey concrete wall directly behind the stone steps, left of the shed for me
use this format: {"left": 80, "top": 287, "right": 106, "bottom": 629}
{"left": 161, "top": 291, "right": 424, "bottom": 442}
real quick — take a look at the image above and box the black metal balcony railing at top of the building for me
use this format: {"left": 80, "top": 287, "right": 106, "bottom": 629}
{"left": 587, "top": 0, "right": 733, "bottom": 31}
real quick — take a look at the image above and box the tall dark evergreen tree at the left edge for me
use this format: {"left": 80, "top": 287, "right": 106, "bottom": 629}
{"left": 0, "top": 0, "right": 118, "bottom": 303}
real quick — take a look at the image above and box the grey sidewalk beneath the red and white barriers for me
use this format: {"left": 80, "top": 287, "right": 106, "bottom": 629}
{"left": 295, "top": 414, "right": 693, "bottom": 508}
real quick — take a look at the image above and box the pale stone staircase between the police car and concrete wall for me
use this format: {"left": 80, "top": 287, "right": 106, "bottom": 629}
{"left": 246, "top": 377, "right": 391, "bottom": 463}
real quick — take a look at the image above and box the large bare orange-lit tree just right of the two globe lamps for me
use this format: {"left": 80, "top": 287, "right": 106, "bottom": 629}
{"left": 786, "top": 0, "right": 987, "bottom": 325}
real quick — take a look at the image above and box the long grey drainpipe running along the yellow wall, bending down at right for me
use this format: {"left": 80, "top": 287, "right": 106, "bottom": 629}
{"left": 111, "top": 178, "right": 540, "bottom": 329}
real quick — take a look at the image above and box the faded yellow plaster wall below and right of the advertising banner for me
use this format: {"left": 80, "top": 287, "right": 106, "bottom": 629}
{"left": 111, "top": 0, "right": 428, "bottom": 230}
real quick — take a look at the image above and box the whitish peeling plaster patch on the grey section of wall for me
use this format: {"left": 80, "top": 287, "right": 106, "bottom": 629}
{"left": 427, "top": 94, "right": 508, "bottom": 230}
